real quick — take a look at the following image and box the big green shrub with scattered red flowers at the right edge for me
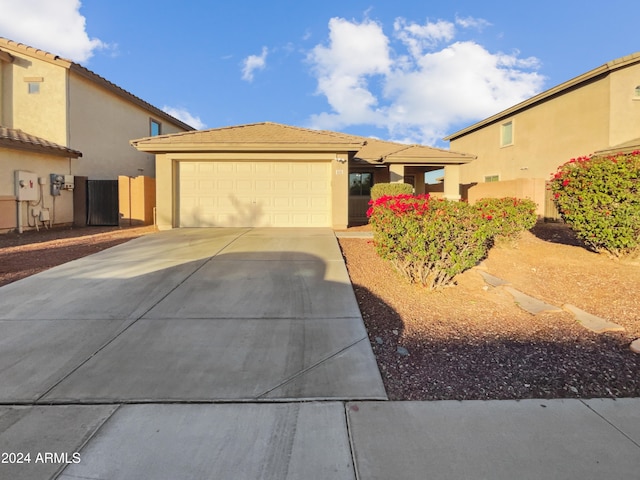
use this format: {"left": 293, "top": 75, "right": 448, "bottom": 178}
{"left": 550, "top": 151, "right": 640, "bottom": 257}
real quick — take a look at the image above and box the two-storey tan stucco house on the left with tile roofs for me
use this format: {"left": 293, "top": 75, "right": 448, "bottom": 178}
{"left": 0, "top": 38, "right": 193, "bottom": 231}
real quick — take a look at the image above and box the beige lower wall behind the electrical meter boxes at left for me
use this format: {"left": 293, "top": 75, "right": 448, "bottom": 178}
{"left": 0, "top": 149, "right": 73, "bottom": 231}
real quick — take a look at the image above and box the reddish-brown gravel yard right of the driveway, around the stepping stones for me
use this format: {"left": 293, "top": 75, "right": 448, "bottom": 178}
{"left": 340, "top": 224, "right": 640, "bottom": 400}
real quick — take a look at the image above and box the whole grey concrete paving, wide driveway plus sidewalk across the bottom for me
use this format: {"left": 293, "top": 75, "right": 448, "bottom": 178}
{"left": 0, "top": 229, "right": 640, "bottom": 480}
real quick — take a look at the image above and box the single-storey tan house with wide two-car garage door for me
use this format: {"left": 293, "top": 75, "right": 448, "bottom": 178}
{"left": 131, "top": 122, "right": 474, "bottom": 229}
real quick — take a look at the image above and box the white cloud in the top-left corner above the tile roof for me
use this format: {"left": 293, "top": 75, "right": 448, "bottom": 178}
{"left": 0, "top": 0, "right": 110, "bottom": 63}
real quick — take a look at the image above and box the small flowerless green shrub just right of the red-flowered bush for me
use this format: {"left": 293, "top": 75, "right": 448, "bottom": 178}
{"left": 474, "top": 197, "right": 538, "bottom": 241}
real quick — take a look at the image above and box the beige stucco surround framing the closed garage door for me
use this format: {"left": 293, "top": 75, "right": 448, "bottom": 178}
{"left": 156, "top": 152, "right": 349, "bottom": 230}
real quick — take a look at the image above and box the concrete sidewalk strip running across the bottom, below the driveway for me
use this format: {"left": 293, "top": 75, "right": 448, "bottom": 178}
{"left": 0, "top": 399, "right": 640, "bottom": 480}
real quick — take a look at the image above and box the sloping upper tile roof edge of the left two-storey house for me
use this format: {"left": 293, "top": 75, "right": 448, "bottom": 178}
{"left": 0, "top": 37, "right": 193, "bottom": 130}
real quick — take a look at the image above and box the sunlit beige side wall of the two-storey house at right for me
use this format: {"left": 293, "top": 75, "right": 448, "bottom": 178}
{"left": 450, "top": 78, "right": 610, "bottom": 188}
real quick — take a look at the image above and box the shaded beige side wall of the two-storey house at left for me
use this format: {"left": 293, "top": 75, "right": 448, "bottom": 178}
{"left": 69, "top": 72, "right": 183, "bottom": 180}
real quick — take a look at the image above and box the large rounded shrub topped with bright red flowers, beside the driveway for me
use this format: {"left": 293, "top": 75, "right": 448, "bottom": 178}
{"left": 367, "top": 195, "right": 492, "bottom": 290}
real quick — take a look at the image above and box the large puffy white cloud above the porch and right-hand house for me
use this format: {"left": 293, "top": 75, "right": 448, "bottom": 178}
{"left": 308, "top": 18, "right": 544, "bottom": 145}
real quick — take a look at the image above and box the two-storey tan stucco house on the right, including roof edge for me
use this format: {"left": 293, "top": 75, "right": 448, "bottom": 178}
{"left": 445, "top": 53, "right": 640, "bottom": 216}
